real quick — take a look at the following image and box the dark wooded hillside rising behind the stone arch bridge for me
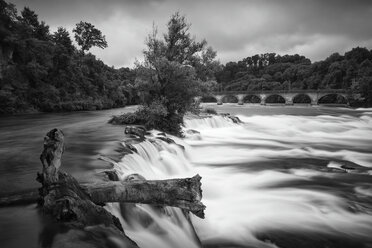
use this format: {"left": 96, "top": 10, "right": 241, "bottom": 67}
{"left": 216, "top": 47, "right": 372, "bottom": 106}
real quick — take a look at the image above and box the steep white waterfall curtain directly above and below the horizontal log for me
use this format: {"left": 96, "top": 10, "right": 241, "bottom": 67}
{"left": 106, "top": 137, "right": 200, "bottom": 248}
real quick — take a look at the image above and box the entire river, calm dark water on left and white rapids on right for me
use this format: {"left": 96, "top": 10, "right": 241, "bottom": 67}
{"left": 0, "top": 104, "right": 372, "bottom": 248}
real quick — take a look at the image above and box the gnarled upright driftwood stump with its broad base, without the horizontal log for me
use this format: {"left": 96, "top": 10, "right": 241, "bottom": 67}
{"left": 37, "top": 129, "right": 138, "bottom": 248}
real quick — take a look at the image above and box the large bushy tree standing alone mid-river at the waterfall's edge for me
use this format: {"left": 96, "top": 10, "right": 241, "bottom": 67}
{"left": 135, "top": 12, "right": 220, "bottom": 135}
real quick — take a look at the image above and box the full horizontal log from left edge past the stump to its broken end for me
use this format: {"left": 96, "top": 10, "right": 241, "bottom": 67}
{"left": 0, "top": 174, "right": 205, "bottom": 218}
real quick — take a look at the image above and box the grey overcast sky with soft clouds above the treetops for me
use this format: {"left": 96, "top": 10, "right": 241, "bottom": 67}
{"left": 8, "top": 0, "right": 372, "bottom": 67}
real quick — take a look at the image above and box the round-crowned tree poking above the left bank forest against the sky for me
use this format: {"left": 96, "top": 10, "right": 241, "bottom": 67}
{"left": 72, "top": 21, "right": 107, "bottom": 54}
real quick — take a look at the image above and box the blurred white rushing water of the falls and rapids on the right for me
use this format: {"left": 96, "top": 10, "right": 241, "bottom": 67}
{"left": 107, "top": 112, "right": 372, "bottom": 247}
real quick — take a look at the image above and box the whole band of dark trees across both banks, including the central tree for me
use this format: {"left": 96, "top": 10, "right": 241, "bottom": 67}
{"left": 0, "top": 0, "right": 372, "bottom": 114}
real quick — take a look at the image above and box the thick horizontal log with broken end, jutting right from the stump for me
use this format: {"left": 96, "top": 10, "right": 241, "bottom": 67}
{"left": 82, "top": 175, "right": 205, "bottom": 218}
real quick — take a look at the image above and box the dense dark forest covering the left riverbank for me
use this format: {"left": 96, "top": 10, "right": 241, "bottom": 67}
{"left": 0, "top": 0, "right": 136, "bottom": 114}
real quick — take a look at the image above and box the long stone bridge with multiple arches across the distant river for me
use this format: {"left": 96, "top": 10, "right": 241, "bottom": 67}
{"left": 195, "top": 90, "right": 352, "bottom": 105}
